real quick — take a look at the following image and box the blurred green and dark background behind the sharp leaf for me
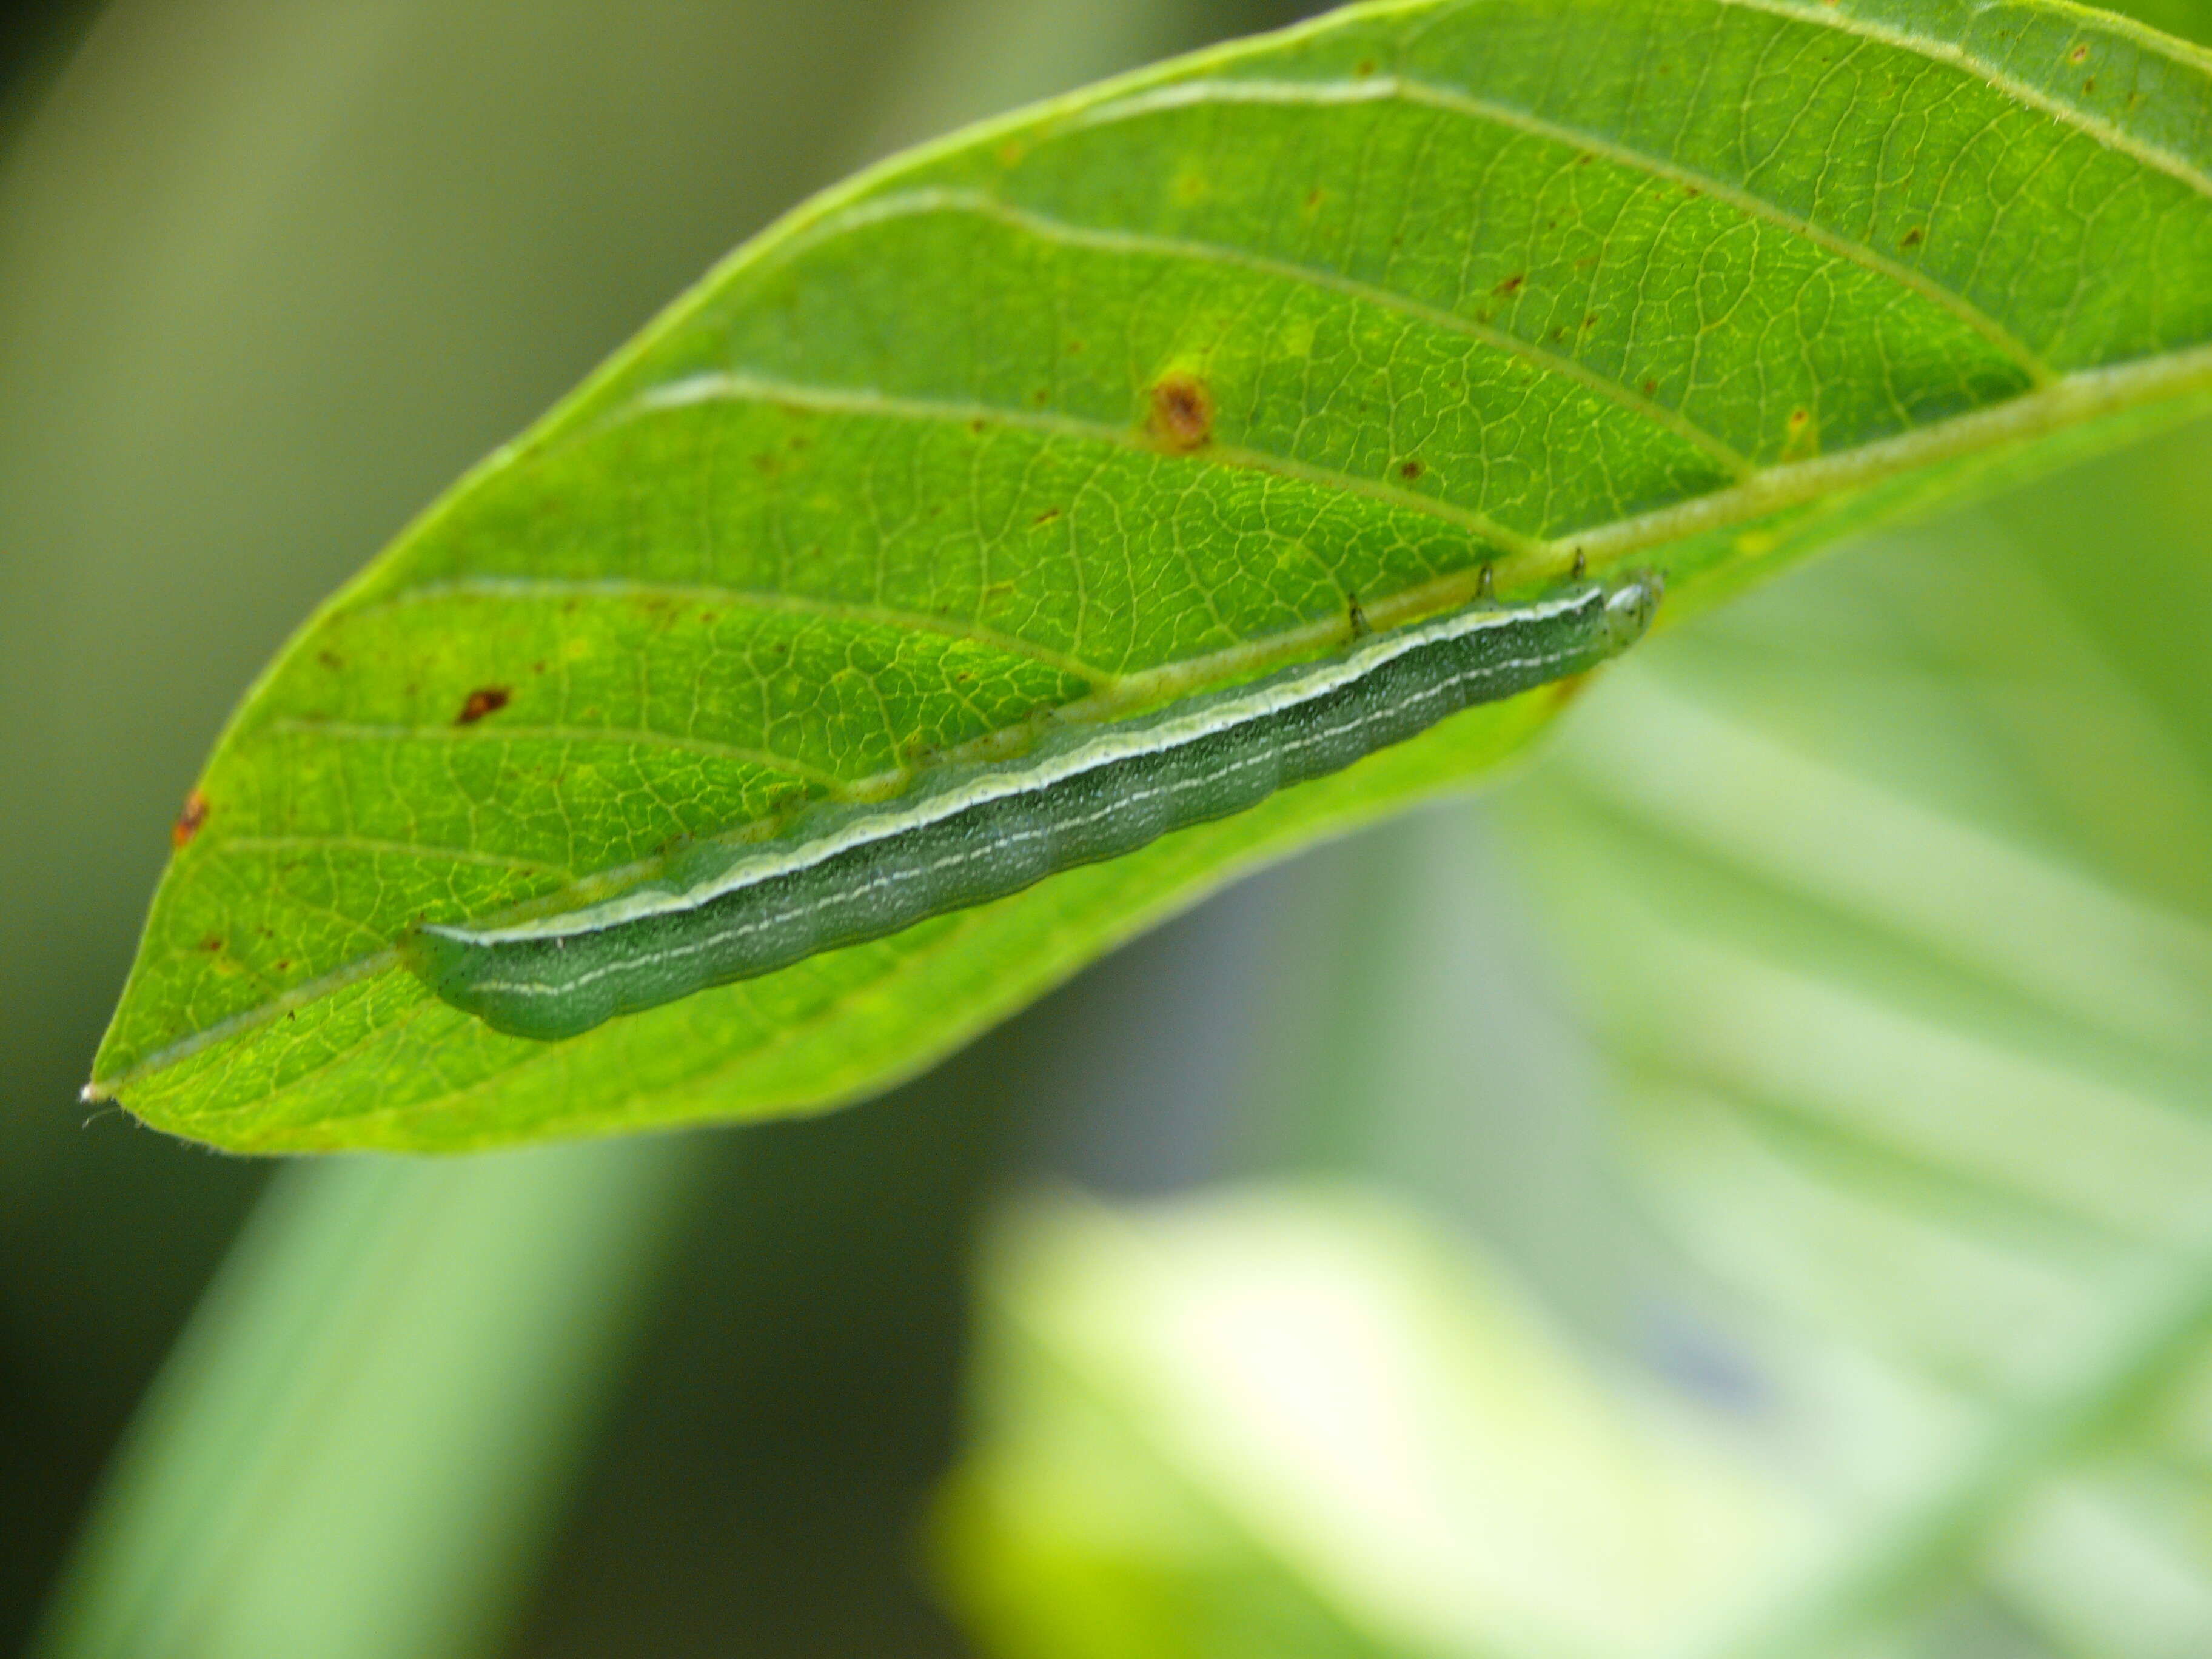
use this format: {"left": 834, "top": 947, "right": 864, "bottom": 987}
{"left": 13, "top": 0, "right": 2212, "bottom": 1655}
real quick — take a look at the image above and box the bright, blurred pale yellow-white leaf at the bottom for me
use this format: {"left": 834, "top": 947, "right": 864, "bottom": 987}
{"left": 940, "top": 1188, "right": 1805, "bottom": 1659}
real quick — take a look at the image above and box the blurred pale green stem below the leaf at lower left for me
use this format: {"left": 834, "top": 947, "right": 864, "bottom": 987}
{"left": 33, "top": 1139, "right": 706, "bottom": 1659}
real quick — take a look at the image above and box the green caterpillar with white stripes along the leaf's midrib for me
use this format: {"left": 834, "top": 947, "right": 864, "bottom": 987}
{"left": 400, "top": 573, "right": 1661, "bottom": 1040}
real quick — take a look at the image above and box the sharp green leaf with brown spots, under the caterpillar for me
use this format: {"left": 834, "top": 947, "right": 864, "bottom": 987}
{"left": 93, "top": 0, "right": 2212, "bottom": 1150}
